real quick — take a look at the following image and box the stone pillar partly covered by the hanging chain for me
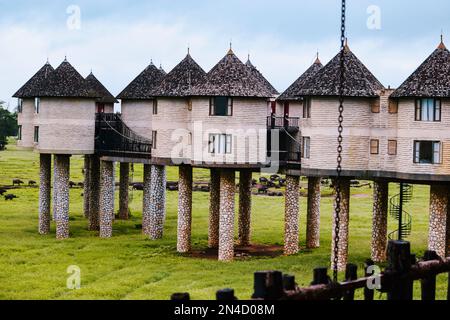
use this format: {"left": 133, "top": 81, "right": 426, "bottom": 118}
{"left": 331, "top": 178, "right": 350, "bottom": 271}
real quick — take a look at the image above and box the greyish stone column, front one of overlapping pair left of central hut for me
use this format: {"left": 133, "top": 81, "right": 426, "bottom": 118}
{"left": 149, "top": 165, "right": 166, "bottom": 240}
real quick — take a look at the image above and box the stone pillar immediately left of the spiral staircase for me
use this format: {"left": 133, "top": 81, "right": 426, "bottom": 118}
{"left": 372, "top": 181, "right": 389, "bottom": 262}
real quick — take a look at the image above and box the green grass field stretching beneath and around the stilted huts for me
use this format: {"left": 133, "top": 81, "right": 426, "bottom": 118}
{"left": 0, "top": 139, "right": 447, "bottom": 299}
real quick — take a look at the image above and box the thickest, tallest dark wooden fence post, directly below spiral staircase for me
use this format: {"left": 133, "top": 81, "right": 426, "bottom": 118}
{"left": 386, "top": 241, "right": 413, "bottom": 300}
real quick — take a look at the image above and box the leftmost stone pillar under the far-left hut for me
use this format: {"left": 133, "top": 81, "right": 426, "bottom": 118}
{"left": 39, "top": 154, "right": 52, "bottom": 234}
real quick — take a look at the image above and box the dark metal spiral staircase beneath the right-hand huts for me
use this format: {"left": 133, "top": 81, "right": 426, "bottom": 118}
{"left": 389, "top": 183, "right": 413, "bottom": 240}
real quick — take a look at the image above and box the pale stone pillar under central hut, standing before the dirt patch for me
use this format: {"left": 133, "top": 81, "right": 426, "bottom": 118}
{"left": 219, "top": 169, "right": 236, "bottom": 261}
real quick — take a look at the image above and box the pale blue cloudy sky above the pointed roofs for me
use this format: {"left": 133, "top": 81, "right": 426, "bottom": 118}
{"left": 0, "top": 0, "right": 450, "bottom": 109}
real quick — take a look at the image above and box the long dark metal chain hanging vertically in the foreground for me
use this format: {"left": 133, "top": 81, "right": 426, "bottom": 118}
{"left": 333, "top": 0, "right": 346, "bottom": 283}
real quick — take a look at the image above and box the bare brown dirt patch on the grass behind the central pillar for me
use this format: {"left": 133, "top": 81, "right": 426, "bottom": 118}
{"left": 188, "top": 245, "right": 283, "bottom": 260}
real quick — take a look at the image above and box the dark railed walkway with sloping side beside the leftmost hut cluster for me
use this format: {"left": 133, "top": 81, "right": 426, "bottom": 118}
{"left": 95, "top": 113, "right": 153, "bottom": 159}
